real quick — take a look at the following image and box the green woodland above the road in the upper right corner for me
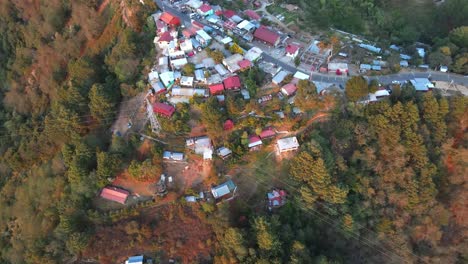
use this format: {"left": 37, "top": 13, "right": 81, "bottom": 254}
{"left": 284, "top": 0, "right": 468, "bottom": 75}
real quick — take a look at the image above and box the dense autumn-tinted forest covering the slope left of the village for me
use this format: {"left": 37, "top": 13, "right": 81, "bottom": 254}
{"left": 0, "top": 0, "right": 156, "bottom": 263}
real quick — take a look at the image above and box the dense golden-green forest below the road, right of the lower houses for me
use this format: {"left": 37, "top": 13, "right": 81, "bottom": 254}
{"left": 213, "top": 90, "right": 468, "bottom": 263}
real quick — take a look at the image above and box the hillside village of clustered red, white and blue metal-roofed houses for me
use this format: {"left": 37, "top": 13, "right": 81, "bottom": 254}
{"left": 96, "top": 0, "right": 468, "bottom": 263}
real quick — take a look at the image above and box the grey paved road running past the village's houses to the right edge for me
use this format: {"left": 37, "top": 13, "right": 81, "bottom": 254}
{"left": 155, "top": 0, "right": 468, "bottom": 86}
